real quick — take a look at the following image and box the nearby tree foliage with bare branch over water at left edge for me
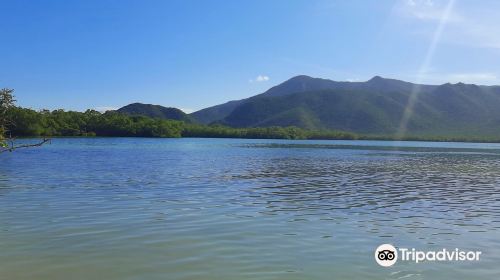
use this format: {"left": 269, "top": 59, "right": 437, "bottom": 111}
{"left": 0, "top": 88, "right": 49, "bottom": 153}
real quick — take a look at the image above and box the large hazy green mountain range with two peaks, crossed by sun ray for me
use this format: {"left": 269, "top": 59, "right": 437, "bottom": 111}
{"left": 192, "top": 75, "right": 500, "bottom": 136}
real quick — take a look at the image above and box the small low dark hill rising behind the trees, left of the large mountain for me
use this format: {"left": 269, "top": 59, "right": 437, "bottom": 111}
{"left": 117, "top": 103, "right": 193, "bottom": 122}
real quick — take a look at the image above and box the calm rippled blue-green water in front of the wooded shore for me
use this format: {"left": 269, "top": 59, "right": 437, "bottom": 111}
{"left": 0, "top": 138, "right": 500, "bottom": 280}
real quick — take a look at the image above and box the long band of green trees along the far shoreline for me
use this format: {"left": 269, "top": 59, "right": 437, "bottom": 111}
{"left": 6, "top": 107, "right": 500, "bottom": 142}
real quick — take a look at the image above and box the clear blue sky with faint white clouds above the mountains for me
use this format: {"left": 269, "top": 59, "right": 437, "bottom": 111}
{"left": 0, "top": 0, "right": 500, "bottom": 112}
